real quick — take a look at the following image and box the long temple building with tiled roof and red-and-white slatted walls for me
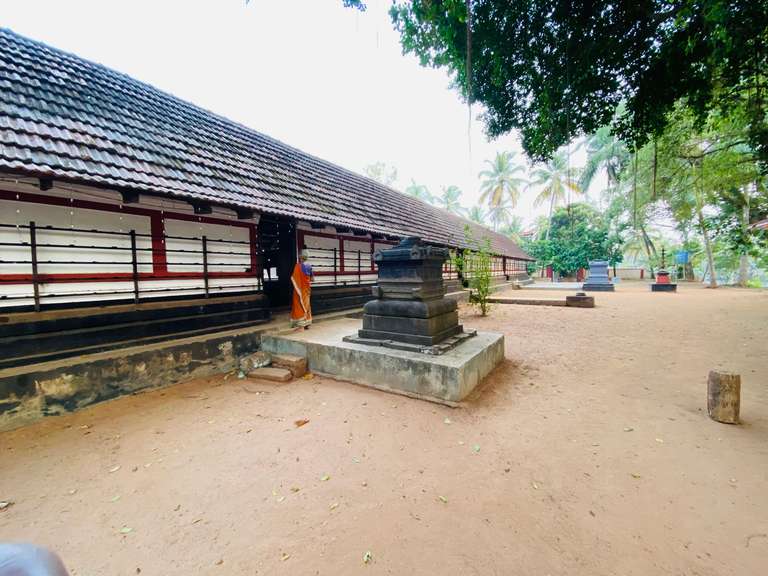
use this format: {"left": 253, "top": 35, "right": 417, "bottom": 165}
{"left": 0, "top": 29, "right": 531, "bottom": 367}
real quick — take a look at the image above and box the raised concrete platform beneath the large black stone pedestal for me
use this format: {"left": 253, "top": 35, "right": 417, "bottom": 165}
{"left": 261, "top": 318, "right": 504, "bottom": 406}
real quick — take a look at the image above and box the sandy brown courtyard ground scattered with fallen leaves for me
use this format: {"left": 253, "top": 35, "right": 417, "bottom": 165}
{"left": 0, "top": 283, "right": 768, "bottom": 576}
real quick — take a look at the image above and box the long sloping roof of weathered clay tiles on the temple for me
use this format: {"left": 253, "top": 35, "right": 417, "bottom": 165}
{"left": 0, "top": 28, "right": 530, "bottom": 259}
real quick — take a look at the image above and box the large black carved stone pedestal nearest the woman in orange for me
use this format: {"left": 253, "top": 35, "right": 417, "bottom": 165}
{"left": 349, "top": 238, "right": 472, "bottom": 354}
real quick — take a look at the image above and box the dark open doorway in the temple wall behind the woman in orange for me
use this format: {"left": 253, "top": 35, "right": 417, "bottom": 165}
{"left": 258, "top": 214, "right": 296, "bottom": 308}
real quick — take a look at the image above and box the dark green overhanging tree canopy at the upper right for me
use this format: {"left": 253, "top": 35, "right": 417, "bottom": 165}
{"left": 380, "top": 0, "right": 768, "bottom": 166}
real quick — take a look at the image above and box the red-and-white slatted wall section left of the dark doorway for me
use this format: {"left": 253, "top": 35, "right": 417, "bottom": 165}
{"left": 0, "top": 174, "right": 260, "bottom": 309}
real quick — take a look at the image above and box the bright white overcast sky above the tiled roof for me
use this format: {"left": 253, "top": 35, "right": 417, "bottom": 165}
{"left": 0, "top": 0, "right": 583, "bottom": 227}
